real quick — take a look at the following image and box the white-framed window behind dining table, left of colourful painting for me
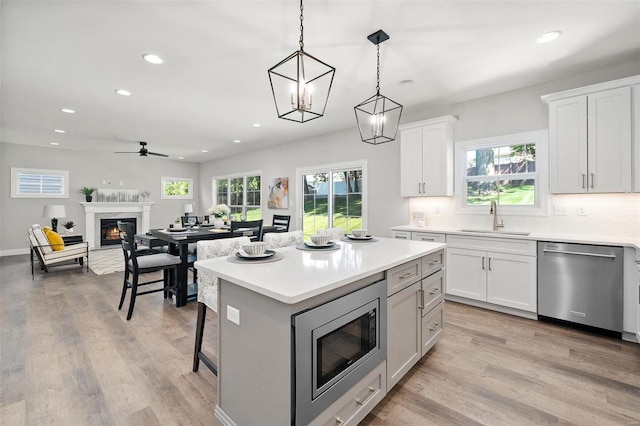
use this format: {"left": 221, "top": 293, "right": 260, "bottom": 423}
{"left": 213, "top": 172, "right": 262, "bottom": 220}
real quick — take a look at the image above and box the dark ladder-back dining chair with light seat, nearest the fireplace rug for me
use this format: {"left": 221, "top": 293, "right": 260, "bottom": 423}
{"left": 118, "top": 221, "right": 180, "bottom": 321}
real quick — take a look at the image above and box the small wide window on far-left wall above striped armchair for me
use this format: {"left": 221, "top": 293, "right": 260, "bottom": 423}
{"left": 11, "top": 167, "right": 69, "bottom": 198}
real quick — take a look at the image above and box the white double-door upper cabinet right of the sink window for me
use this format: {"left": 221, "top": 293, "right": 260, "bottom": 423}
{"left": 543, "top": 77, "right": 635, "bottom": 194}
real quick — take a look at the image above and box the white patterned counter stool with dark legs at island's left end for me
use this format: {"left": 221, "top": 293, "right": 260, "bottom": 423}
{"left": 193, "top": 237, "right": 251, "bottom": 375}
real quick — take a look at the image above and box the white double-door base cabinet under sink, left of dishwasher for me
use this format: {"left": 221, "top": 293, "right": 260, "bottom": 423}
{"left": 446, "top": 238, "right": 538, "bottom": 313}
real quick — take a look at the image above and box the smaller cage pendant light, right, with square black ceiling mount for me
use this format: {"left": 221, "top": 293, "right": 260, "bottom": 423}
{"left": 354, "top": 30, "right": 402, "bottom": 145}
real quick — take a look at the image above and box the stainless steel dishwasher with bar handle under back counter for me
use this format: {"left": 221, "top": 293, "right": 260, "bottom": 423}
{"left": 538, "top": 241, "right": 623, "bottom": 333}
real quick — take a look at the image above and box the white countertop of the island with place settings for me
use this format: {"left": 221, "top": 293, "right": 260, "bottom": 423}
{"left": 195, "top": 238, "right": 445, "bottom": 304}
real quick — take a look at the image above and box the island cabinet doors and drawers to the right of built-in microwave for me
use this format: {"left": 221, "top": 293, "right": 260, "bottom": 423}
{"left": 387, "top": 250, "right": 444, "bottom": 392}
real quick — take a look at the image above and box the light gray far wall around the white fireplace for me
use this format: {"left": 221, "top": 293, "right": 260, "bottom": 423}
{"left": 0, "top": 143, "right": 199, "bottom": 255}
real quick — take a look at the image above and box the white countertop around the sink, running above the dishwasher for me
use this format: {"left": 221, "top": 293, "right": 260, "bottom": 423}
{"left": 391, "top": 225, "right": 640, "bottom": 249}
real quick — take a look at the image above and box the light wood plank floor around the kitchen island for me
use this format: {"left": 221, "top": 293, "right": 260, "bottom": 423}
{"left": 0, "top": 256, "right": 640, "bottom": 425}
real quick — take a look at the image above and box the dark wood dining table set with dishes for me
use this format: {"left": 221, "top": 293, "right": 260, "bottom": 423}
{"left": 149, "top": 225, "right": 282, "bottom": 307}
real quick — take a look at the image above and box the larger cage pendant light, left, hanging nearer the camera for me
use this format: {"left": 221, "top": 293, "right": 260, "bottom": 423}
{"left": 269, "top": 0, "right": 336, "bottom": 123}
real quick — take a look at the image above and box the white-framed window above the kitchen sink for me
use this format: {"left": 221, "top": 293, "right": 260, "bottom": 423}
{"left": 456, "top": 131, "right": 547, "bottom": 214}
